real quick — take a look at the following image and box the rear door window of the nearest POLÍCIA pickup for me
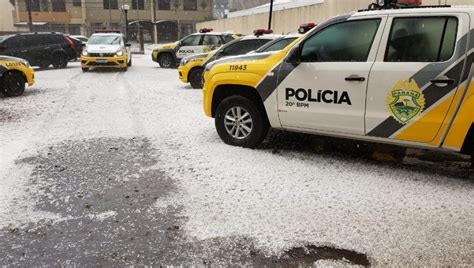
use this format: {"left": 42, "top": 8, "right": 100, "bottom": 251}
{"left": 385, "top": 17, "right": 458, "bottom": 62}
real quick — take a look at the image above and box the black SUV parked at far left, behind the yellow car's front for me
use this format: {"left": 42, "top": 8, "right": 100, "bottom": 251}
{"left": 0, "top": 33, "right": 77, "bottom": 68}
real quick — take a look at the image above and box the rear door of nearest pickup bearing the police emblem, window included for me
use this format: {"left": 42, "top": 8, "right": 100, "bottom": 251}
{"left": 366, "top": 14, "right": 469, "bottom": 143}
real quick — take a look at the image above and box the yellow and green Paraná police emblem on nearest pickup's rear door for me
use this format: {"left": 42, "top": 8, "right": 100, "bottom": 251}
{"left": 387, "top": 80, "right": 425, "bottom": 125}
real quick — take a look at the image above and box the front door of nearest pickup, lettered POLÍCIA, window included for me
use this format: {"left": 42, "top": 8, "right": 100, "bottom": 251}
{"left": 277, "top": 17, "right": 385, "bottom": 135}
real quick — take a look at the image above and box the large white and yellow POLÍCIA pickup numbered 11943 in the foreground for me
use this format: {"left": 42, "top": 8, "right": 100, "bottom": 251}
{"left": 203, "top": 2, "right": 474, "bottom": 163}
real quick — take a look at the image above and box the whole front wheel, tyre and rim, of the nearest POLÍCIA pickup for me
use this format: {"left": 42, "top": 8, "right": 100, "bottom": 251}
{"left": 215, "top": 96, "right": 269, "bottom": 148}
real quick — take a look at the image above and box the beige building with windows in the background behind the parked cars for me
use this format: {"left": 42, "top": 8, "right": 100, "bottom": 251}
{"left": 14, "top": 0, "right": 213, "bottom": 42}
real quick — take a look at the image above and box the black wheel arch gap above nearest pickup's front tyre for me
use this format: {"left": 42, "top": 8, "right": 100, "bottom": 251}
{"left": 211, "top": 84, "right": 268, "bottom": 118}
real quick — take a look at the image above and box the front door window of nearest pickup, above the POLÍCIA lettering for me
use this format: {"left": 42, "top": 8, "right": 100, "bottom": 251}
{"left": 301, "top": 19, "right": 380, "bottom": 62}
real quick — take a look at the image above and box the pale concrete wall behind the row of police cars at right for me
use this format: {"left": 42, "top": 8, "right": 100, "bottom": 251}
{"left": 196, "top": 0, "right": 474, "bottom": 34}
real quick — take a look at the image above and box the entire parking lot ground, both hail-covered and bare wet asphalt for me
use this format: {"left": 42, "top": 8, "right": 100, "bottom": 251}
{"left": 0, "top": 54, "right": 474, "bottom": 266}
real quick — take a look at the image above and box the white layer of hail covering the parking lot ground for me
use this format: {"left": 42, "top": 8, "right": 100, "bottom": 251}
{"left": 0, "top": 55, "right": 474, "bottom": 265}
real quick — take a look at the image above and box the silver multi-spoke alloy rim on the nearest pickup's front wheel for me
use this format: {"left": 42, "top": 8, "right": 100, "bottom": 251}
{"left": 224, "top": 106, "right": 253, "bottom": 140}
